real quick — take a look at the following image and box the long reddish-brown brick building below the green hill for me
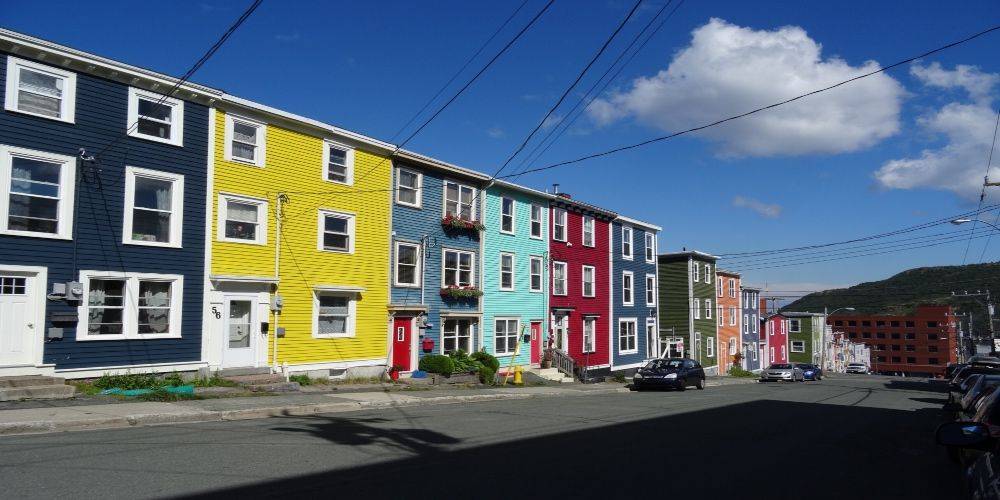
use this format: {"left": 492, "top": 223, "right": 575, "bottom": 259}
{"left": 830, "top": 305, "right": 958, "bottom": 375}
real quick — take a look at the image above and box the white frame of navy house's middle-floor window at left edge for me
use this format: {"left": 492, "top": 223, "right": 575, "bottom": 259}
{"left": 0, "top": 145, "right": 76, "bottom": 240}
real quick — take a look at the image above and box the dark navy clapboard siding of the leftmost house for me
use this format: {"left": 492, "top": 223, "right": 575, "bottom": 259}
{"left": 0, "top": 53, "right": 208, "bottom": 370}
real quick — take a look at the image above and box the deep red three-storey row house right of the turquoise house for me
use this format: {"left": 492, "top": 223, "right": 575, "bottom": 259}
{"left": 549, "top": 193, "right": 617, "bottom": 379}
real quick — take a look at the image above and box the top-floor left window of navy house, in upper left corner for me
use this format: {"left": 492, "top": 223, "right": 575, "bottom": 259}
{"left": 4, "top": 56, "right": 76, "bottom": 123}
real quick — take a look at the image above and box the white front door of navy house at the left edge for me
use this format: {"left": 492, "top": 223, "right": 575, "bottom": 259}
{"left": 0, "top": 275, "right": 35, "bottom": 366}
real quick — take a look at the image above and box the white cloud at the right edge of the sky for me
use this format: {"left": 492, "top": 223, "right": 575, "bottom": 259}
{"left": 875, "top": 64, "right": 1000, "bottom": 200}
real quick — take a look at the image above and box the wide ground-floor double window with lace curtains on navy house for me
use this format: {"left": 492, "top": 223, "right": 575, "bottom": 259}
{"left": 76, "top": 271, "right": 184, "bottom": 341}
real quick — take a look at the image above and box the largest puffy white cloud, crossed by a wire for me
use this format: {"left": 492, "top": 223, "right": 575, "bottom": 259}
{"left": 587, "top": 19, "right": 905, "bottom": 156}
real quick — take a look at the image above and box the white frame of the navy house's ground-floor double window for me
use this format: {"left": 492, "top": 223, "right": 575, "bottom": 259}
{"left": 76, "top": 270, "right": 184, "bottom": 342}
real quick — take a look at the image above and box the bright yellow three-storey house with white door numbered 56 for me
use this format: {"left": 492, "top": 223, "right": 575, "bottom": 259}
{"left": 203, "top": 96, "right": 392, "bottom": 375}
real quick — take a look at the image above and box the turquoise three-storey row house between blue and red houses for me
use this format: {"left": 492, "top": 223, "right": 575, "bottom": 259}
{"left": 481, "top": 181, "right": 551, "bottom": 372}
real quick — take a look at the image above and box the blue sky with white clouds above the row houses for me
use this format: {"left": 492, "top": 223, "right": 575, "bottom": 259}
{"left": 2, "top": 0, "right": 1000, "bottom": 298}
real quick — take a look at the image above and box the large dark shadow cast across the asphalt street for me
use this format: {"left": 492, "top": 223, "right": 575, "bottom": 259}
{"left": 180, "top": 394, "right": 959, "bottom": 500}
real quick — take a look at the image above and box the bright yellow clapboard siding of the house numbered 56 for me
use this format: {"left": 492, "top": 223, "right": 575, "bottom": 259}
{"left": 212, "top": 110, "right": 391, "bottom": 365}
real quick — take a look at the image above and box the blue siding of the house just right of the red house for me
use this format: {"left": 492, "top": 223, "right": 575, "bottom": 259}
{"left": 611, "top": 220, "right": 659, "bottom": 369}
